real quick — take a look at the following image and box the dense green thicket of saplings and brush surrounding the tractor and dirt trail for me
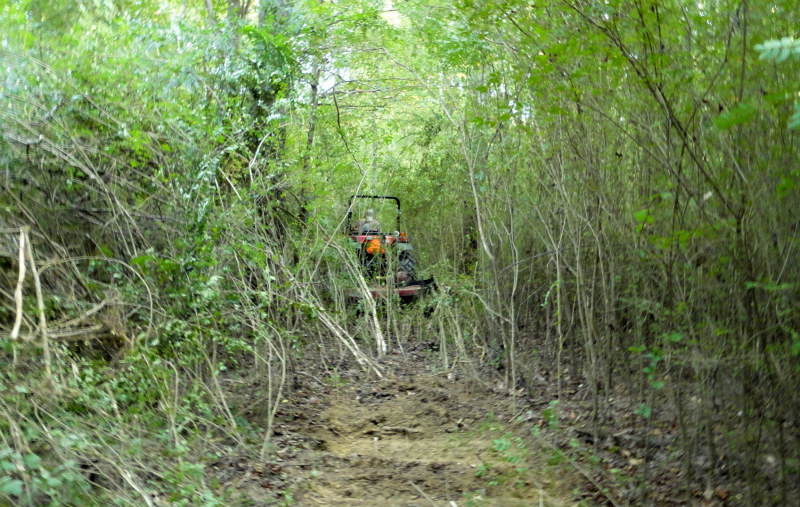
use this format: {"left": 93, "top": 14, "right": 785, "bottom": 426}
{"left": 0, "top": 0, "right": 800, "bottom": 506}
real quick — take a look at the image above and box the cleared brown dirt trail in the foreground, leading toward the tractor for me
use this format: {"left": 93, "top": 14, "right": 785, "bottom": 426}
{"left": 259, "top": 353, "right": 596, "bottom": 507}
